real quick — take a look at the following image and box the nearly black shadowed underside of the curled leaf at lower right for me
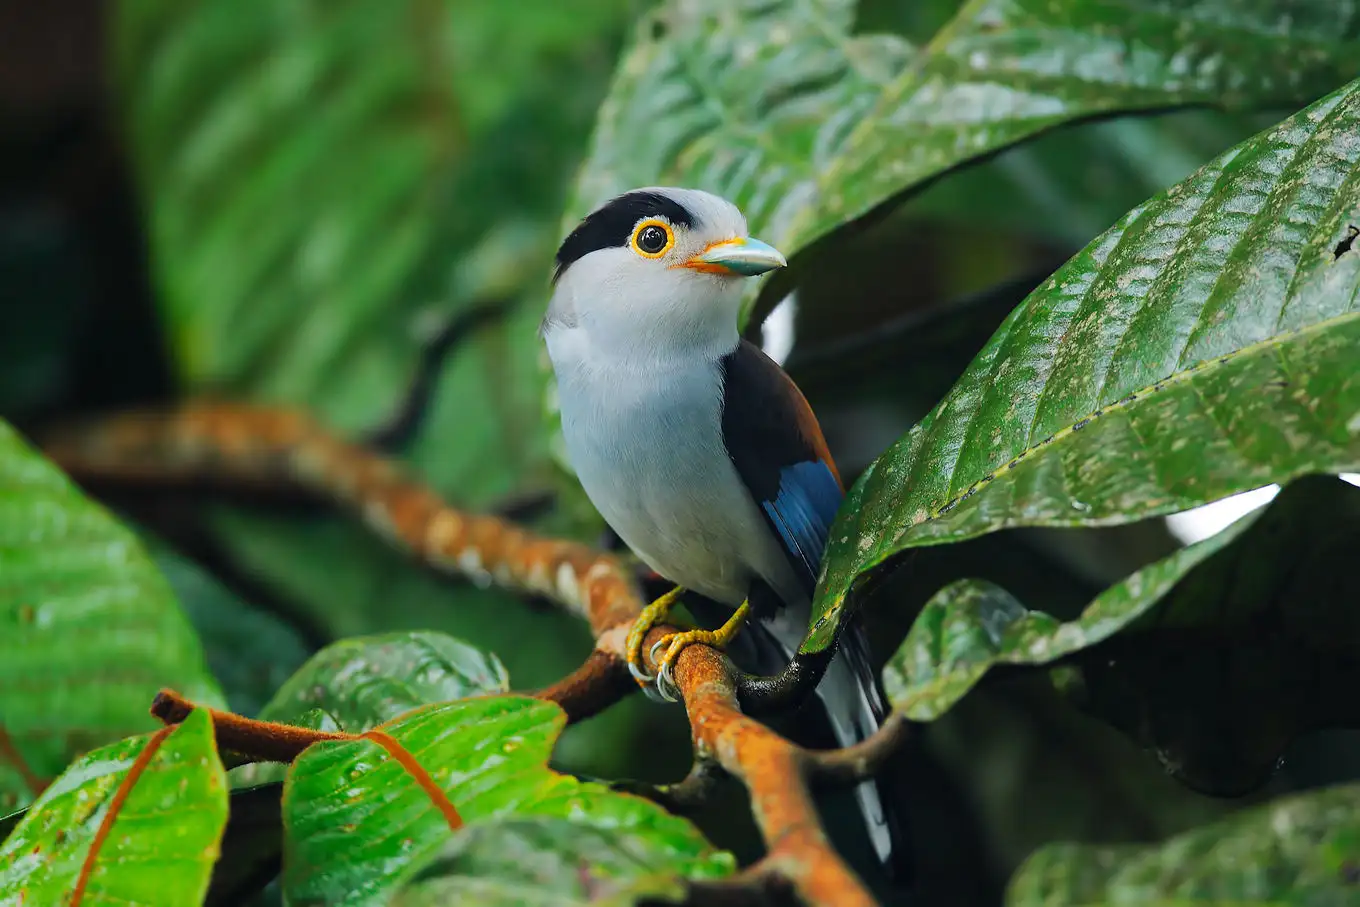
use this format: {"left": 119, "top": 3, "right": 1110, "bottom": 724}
{"left": 1055, "top": 476, "right": 1360, "bottom": 797}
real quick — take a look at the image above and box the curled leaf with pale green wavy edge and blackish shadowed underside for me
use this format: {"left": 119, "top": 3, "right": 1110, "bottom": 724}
{"left": 884, "top": 476, "right": 1360, "bottom": 795}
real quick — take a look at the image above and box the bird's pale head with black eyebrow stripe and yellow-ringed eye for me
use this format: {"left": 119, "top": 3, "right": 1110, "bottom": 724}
{"left": 544, "top": 186, "right": 786, "bottom": 358}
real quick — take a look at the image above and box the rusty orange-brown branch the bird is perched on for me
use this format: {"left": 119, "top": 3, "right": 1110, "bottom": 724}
{"left": 45, "top": 405, "right": 907, "bottom": 907}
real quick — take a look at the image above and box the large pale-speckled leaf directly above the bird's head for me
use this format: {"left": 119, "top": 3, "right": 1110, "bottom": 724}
{"left": 570, "top": 0, "right": 1360, "bottom": 303}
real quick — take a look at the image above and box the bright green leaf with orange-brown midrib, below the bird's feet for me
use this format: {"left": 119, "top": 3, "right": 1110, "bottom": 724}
{"left": 283, "top": 696, "right": 732, "bottom": 904}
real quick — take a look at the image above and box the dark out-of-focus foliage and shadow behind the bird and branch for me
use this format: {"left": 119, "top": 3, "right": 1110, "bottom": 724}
{"left": 0, "top": 0, "right": 1360, "bottom": 904}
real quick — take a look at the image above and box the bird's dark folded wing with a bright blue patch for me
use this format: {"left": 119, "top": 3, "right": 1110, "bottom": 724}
{"left": 722, "top": 340, "right": 845, "bottom": 596}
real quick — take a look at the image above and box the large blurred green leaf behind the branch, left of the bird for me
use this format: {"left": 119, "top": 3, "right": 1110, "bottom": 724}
{"left": 114, "top": 0, "right": 658, "bottom": 794}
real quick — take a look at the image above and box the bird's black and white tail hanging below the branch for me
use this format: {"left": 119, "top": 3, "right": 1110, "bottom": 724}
{"left": 817, "top": 621, "right": 911, "bottom": 881}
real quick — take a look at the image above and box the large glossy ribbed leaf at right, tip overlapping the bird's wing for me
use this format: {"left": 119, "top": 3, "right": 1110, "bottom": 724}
{"left": 804, "top": 72, "right": 1360, "bottom": 651}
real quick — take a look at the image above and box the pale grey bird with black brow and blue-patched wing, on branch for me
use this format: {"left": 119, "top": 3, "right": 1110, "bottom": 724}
{"left": 540, "top": 186, "right": 902, "bottom": 866}
